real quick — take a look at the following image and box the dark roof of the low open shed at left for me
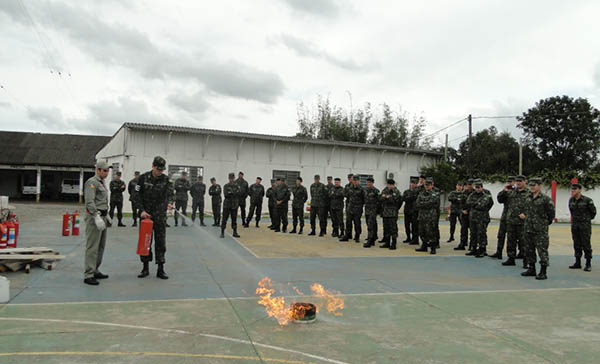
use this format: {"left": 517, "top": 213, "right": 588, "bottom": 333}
{"left": 0, "top": 131, "right": 111, "bottom": 167}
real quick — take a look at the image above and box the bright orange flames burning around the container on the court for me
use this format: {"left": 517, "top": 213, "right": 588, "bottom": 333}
{"left": 256, "top": 277, "right": 344, "bottom": 326}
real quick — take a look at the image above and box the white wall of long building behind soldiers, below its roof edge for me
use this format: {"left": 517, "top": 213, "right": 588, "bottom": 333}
{"left": 97, "top": 129, "right": 434, "bottom": 211}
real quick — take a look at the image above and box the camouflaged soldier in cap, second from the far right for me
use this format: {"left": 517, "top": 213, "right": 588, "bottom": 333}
{"left": 519, "top": 178, "right": 555, "bottom": 279}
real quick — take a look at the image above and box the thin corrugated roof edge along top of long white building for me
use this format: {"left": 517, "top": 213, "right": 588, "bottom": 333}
{"left": 120, "top": 123, "right": 442, "bottom": 156}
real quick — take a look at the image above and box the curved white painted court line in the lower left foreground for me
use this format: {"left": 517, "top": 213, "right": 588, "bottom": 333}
{"left": 0, "top": 317, "right": 348, "bottom": 364}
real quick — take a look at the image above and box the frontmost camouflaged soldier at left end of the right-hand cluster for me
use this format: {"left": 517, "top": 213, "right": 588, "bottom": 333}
{"left": 464, "top": 179, "right": 493, "bottom": 258}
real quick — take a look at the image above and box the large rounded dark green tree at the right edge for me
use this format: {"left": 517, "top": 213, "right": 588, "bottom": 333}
{"left": 517, "top": 96, "right": 600, "bottom": 172}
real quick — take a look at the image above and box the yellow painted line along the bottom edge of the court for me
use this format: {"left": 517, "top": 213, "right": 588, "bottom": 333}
{"left": 0, "top": 351, "right": 314, "bottom": 364}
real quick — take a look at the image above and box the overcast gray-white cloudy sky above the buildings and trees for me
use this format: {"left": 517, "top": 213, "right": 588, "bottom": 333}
{"left": 0, "top": 0, "right": 600, "bottom": 144}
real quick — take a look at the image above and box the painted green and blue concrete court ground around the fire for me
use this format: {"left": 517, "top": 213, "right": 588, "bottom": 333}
{"left": 0, "top": 204, "right": 600, "bottom": 363}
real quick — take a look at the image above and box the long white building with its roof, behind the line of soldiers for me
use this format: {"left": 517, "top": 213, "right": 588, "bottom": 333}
{"left": 96, "top": 123, "right": 441, "bottom": 212}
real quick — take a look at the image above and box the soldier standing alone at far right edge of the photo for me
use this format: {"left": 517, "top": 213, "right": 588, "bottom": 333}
{"left": 569, "top": 183, "right": 596, "bottom": 272}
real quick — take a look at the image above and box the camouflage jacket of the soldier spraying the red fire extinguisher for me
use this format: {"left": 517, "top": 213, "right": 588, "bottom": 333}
{"left": 138, "top": 171, "right": 174, "bottom": 222}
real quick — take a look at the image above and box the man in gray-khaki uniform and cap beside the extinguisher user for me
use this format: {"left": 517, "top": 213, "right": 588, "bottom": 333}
{"left": 83, "top": 161, "right": 110, "bottom": 286}
